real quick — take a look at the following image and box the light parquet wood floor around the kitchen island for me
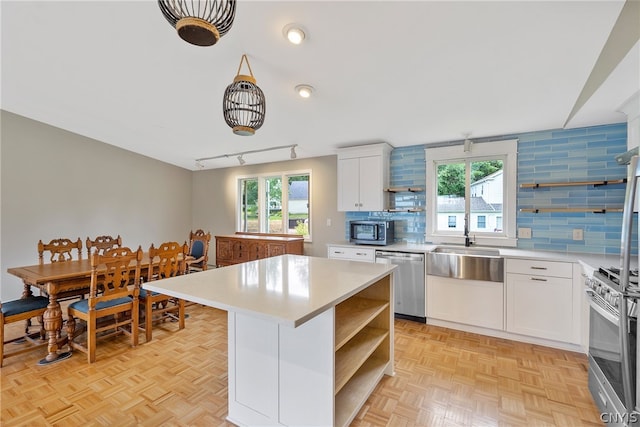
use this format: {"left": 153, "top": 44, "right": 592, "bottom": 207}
{"left": 0, "top": 305, "right": 603, "bottom": 427}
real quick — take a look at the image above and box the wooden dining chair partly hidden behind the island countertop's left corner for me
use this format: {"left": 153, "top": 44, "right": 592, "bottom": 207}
{"left": 140, "top": 242, "right": 189, "bottom": 342}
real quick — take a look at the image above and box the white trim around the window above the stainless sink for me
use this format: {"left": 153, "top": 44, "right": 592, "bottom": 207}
{"left": 425, "top": 139, "right": 518, "bottom": 247}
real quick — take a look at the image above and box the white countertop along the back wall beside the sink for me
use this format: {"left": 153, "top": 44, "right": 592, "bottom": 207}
{"left": 328, "top": 241, "right": 638, "bottom": 269}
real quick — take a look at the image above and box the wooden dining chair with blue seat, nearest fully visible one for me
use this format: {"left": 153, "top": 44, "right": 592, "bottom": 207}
{"left": 66, "top": 247, "right": 142, "bottom": 363}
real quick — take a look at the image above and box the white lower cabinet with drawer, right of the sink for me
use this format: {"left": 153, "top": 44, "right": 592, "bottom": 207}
{"left": 506, "top": 259, "right": 579, "bottom": 343}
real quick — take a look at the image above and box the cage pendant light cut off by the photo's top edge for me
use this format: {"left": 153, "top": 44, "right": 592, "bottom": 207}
{"left": 158, "top": 0, "right": 236, "bottom": 46}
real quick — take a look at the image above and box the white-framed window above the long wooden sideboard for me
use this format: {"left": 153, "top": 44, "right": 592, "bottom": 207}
{"left": 236, "top": 171, "right": 311, "bottom": 240}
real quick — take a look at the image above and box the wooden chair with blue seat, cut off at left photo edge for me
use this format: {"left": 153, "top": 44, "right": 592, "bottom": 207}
{"left": 0, "top": 295, "right": 49, "bottom": 367}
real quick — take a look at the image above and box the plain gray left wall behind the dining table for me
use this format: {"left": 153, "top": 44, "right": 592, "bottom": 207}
{"left": 0, "top": 111, "right": 192, "bottom": 300}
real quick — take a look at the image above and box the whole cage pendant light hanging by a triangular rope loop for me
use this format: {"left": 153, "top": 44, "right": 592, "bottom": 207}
{"left": 222, "top": 55, "right": 267, "bottom": 136}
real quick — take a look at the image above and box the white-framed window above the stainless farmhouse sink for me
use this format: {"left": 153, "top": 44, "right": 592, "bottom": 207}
{"left": 425, "top": 140, "right": 517, "bottom": 246}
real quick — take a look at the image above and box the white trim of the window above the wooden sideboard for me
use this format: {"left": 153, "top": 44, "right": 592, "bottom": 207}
{"left": 235, "top": 169, "right": 313, "bottom": 243}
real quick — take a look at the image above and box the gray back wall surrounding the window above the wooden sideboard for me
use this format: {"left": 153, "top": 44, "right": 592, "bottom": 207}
{"left": 192, "top": 156, "right": 345, "bottom": 263}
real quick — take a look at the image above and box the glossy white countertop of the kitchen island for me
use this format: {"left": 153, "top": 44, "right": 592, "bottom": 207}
{"left": 142, "top": 255, "right": 396, "bottom": 327}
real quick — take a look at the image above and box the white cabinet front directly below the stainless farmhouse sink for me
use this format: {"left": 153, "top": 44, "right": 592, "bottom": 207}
{"left": 427, "top": 276, "right": 504, "bottom": 329}
